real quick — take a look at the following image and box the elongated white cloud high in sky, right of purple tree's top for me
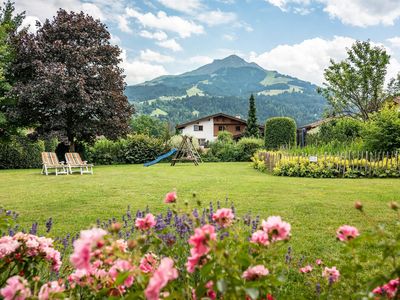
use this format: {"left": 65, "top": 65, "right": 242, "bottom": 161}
{"left": 126, "top": 8, "right": 204, "bottom": 38}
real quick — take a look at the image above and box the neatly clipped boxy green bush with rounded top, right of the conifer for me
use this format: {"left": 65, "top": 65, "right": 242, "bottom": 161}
{"left": 264, "top": 117, "right": 296, "bottom": 149}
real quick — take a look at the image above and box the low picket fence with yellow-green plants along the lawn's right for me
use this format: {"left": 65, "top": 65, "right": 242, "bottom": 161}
{"left": 253, "top": 151, "right": 400, "bottom": 177}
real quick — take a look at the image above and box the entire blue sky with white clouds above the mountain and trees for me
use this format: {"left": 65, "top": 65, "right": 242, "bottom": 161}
{"left": 16, "top": 0, "right": 400, "bottom": 84}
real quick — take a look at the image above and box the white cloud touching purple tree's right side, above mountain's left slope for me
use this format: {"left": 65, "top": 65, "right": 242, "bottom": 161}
{"left": 121, "top": 50, "right": 167, "bottom": 85}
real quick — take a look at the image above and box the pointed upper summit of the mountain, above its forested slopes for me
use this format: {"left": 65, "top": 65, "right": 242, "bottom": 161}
{"left": 181, "top": 54, "right": 263, "bottom": 76}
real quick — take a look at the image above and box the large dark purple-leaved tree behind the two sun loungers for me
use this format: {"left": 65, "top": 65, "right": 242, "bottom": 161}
{"left": 10, "top": 9, "right": 132, "bottom": 151}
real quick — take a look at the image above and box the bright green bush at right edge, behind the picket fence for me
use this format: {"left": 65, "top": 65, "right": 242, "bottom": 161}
{"left": 363, "top": 107, "right": 400, "bottom": 152}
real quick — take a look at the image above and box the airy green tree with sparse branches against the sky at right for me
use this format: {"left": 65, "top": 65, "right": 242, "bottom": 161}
{"left": 318, "top": 41, "right": 390, "bottom": 121}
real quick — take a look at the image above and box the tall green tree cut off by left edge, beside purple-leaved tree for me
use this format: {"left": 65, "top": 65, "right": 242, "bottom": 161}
{"left": 0, "top": 0, "right": 24, "bottom": 140}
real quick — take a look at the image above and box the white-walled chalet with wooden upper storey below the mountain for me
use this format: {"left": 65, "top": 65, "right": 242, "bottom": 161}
{"left": 176, "top": 113, "right": 264, "bottom": 146}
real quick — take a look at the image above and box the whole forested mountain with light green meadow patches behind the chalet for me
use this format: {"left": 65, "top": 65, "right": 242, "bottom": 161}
{"left": 125, "top": 55, "right": 326, "bottom": 125}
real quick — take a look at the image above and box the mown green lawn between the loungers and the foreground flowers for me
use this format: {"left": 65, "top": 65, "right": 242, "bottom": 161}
{"left": 0, "top": 163, "right": 400, "bottom": 257}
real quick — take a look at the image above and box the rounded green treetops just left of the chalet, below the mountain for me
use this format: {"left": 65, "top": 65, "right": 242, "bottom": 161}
{"left": 130, "top": 115, "right": 169, "bottom": 139}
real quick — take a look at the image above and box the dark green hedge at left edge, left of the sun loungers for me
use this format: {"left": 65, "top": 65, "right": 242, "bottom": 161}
{"left": 0, "top": 136, "right": 45, "bottom": 169}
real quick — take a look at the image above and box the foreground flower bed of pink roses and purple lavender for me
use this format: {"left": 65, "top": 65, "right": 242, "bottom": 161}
{"left": 0, "top": 192, "right": 400, "bottom": 300}
